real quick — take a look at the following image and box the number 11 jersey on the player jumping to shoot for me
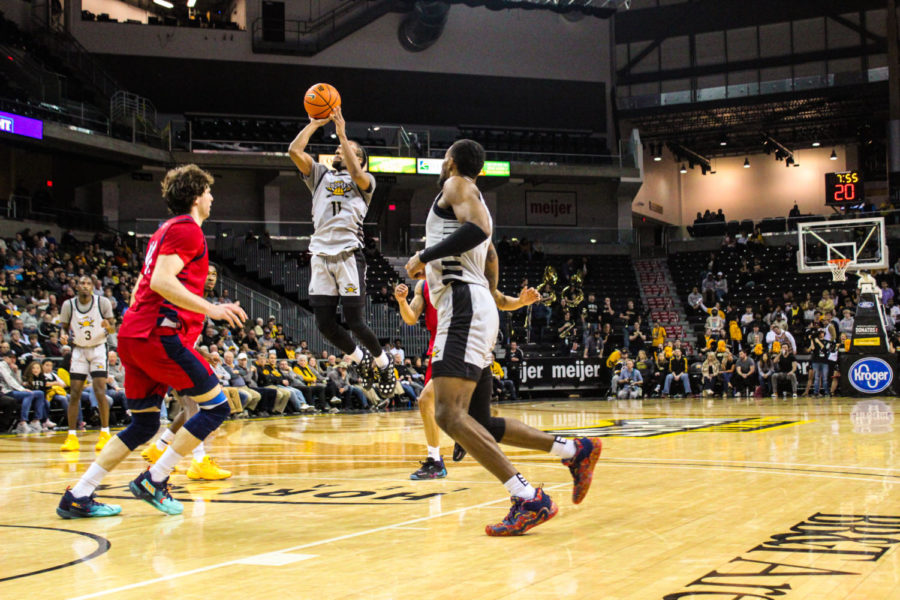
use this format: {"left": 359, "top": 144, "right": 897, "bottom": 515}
{"left": 301, "top": 163, "right": 375, "bottom": 256}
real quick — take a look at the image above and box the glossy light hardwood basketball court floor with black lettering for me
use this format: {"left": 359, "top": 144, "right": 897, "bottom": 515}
{"left": 0, "top": 398, "right": 900, "bottom": 600}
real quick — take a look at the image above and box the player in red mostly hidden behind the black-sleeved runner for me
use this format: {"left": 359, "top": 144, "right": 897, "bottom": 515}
{"left": 394, "top": 255, "right": 541, "bottom": 480}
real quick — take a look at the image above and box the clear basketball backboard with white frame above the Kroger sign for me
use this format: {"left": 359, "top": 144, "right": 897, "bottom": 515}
{"left": 797, "top": 217, "right": 890, "bottom": 273}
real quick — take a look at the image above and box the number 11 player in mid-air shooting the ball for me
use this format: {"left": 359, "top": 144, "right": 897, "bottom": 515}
{"left": 289, "top": 108, "right": 396, "bottom": 398}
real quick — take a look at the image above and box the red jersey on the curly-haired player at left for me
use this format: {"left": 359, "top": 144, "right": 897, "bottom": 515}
{"left": 119, "top": 215, "right": 209, "bottom": 344}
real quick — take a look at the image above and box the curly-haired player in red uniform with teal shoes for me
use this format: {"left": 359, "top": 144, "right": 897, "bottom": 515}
{"left": 56, "top": 165, "right": 247, "bottom": 519}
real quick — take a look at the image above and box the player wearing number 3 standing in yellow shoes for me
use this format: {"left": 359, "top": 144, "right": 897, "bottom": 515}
{"left": 59, "top": 275, "right": 116, "bottom": 452}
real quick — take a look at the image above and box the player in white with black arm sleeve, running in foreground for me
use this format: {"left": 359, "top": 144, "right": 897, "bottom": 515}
{"left": 406, "top": 140, "right": 601, "bottom": 536}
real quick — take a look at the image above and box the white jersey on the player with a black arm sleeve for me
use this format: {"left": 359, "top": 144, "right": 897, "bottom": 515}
{"left": 425, "top": 184, "right": 494, "bottom": 306}
